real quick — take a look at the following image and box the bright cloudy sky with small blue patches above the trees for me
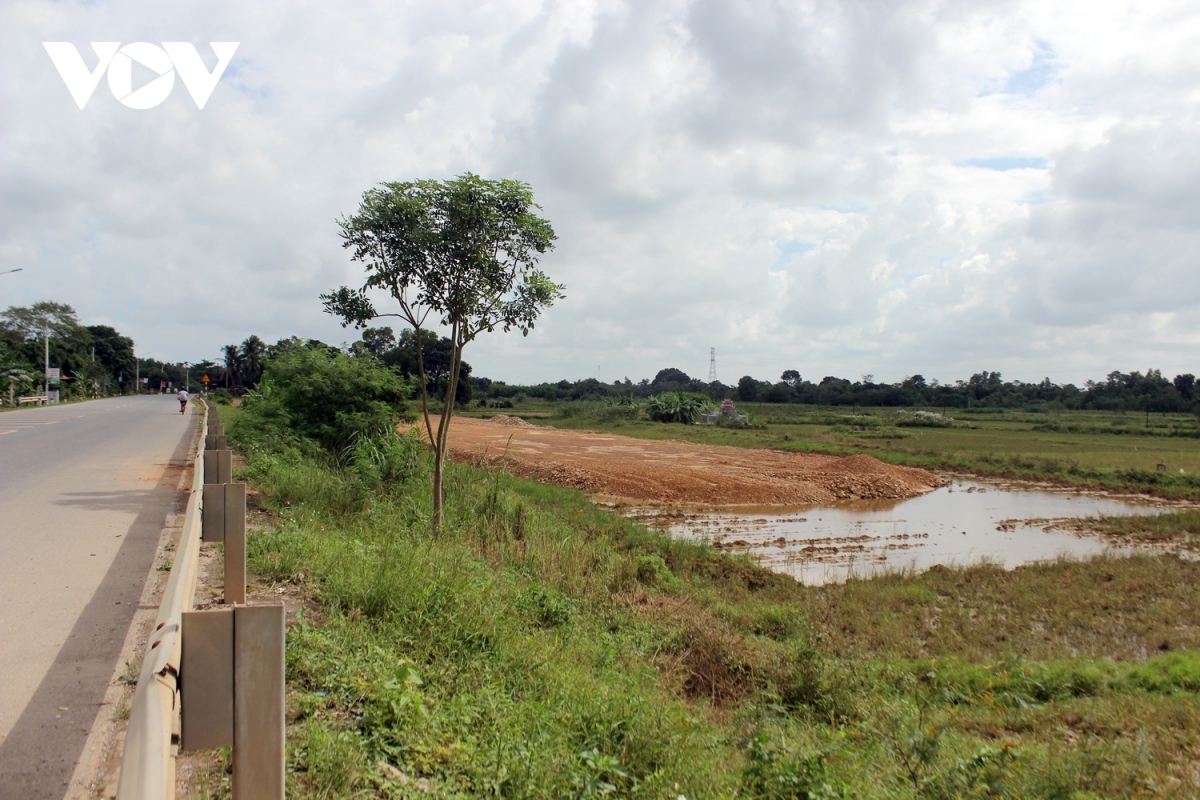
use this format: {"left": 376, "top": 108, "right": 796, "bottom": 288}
{"left": 0, "top": 0, "right": 1200, "bottom": 384}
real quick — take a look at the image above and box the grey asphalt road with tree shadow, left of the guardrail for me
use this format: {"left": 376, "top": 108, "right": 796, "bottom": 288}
{"left": 0, "top": 395, "right": 197, "bottom": 800}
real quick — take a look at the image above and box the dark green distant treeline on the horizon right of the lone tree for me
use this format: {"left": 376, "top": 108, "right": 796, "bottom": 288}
{"left": 470, "top": 368, "right": 1200, "bottom": 411}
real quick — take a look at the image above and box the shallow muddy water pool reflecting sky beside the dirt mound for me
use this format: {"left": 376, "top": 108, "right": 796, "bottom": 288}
{"left": 632, "top": 481, "right": 1158, "bottom": 584}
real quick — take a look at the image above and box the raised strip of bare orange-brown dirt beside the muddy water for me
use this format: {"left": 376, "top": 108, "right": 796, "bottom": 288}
{"left": 439, "top": 415, "right": 940, "bottom": 506}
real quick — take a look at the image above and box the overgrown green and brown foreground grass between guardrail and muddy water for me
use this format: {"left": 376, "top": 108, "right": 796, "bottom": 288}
{"left": 213, "top": 408, "right": 1200, "bottom": 800}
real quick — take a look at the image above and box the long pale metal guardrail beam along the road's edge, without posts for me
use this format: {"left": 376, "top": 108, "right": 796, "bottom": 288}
{"left": 116, "top": 401, "right": 209, "bottom": 800}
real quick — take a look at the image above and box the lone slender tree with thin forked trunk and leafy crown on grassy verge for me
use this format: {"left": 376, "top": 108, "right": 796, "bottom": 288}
{"left": 320, "top": 173, "right": 563, "bottom": 530}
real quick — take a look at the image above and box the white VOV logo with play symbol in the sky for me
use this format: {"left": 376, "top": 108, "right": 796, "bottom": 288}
{"left": 42, "top": 42, "right": 240, "bottom": 109}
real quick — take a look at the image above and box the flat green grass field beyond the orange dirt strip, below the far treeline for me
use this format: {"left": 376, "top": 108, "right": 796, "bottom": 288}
{"left": 470, "top": 403, "right": 1200, "bottom": 500}
